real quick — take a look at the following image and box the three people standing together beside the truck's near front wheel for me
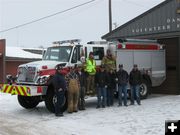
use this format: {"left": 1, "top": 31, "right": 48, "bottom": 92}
{"left": 52, "top": 64, "right": 87, "bottom": 117}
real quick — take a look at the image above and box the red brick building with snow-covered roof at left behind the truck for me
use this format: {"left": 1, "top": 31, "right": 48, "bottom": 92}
{"left": 0, "top": 39, "right": 42, "bottom": 83}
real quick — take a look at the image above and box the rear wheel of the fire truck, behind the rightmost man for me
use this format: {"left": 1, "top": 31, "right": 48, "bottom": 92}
{"left": 140, "top": 79, "right": 150, "bottom": 99}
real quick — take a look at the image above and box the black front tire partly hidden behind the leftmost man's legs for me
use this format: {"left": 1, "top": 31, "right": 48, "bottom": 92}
{"left": 45, "top": 88, "right": 67, "bottom": 113}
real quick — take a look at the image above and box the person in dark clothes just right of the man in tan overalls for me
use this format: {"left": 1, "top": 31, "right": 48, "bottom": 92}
{"left": 77, "top": 66, "right": 86, "bottom": 110}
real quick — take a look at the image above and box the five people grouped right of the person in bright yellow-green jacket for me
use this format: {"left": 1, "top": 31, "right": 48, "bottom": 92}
{"left": 95, "top": 50, "right": 142, "bottom": 108}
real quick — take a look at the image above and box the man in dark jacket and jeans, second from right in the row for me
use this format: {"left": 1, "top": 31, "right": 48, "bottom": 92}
{"left": 117, "top": 64, "right": 129, "bottom": 106}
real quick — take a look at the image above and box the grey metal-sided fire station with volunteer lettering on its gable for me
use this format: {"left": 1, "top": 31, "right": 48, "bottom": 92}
{"left": 102, "top": 0, "right": 180, "bottom": 94}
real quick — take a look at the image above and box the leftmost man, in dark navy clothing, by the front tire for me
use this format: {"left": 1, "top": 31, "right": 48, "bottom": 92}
{"left": 53, "top": 64, "right": 66, "bottom": 117}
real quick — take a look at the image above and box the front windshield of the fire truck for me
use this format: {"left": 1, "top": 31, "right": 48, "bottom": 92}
{"left": 43, "top": 46, "right": 72, "bottom": 62}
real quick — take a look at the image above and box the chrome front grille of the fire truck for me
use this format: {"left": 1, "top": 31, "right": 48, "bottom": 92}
{"left": 17, "top": 66, "right": 36, "bottom": 82}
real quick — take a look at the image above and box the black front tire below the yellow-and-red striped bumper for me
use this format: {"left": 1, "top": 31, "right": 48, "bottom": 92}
{"left": 18, "top": 95, "right": 40, "bottom": 109}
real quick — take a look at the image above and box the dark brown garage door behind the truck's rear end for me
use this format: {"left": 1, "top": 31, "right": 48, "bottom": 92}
{"left": 153, "top": 38, "right": 179, "bottom": 94}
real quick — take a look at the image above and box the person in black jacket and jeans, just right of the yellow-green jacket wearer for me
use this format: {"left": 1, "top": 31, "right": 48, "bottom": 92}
{"left": 95, "top": 65, "right": 108, "bottom": 108}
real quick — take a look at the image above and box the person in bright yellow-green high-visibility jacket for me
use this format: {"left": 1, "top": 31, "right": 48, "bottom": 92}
{"left": 85, "top": 52, "right": 96, "bottom": 94}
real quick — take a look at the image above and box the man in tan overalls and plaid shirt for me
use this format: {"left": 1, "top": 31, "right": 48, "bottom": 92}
{"left": 66, "top": 65, "right": 80, "bottom": 113}
